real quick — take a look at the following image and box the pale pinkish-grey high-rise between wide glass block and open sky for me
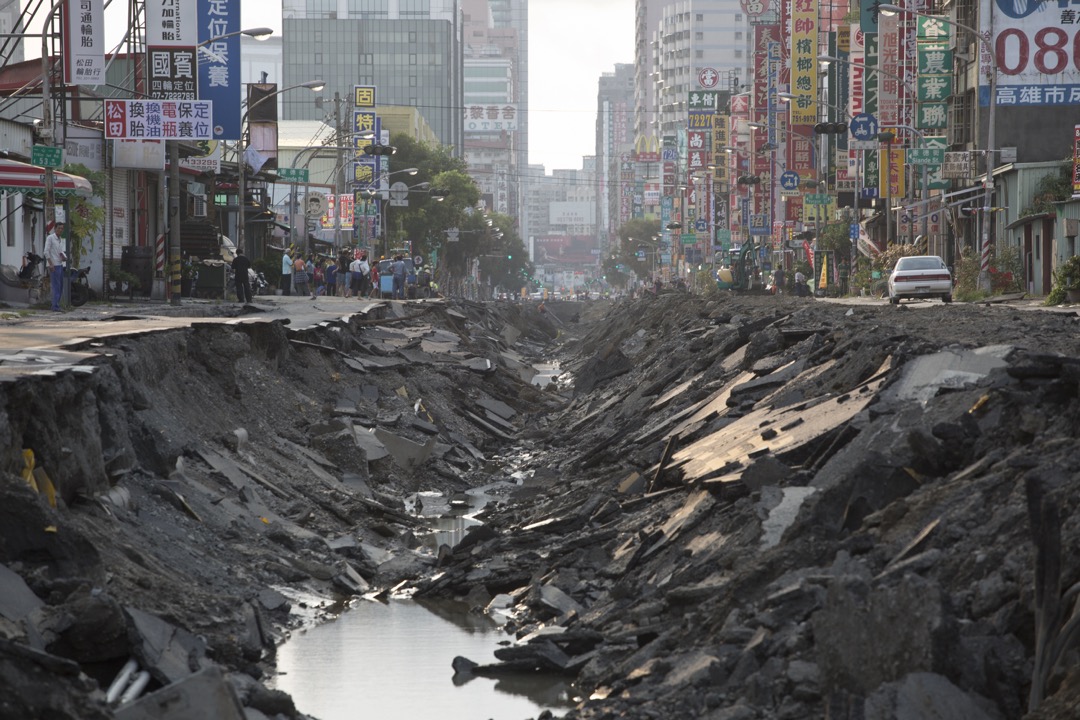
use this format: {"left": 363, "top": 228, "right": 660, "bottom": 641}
{"left": 462, "top": 0, "right": 528, "bottom": 217}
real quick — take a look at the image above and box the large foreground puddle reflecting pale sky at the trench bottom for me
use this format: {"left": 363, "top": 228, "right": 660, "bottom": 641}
{"left": 273, "top": 599, "right": 573, "bottom": 720}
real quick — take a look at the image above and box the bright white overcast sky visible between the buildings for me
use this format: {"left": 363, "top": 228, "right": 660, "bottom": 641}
{"left": 241, "top": 0, "right": 634, "bottom": 173}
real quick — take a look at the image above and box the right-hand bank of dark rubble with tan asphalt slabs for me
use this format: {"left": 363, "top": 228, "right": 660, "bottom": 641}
{"left": 418, "top": 296, "right": 1080, "bottom": 720}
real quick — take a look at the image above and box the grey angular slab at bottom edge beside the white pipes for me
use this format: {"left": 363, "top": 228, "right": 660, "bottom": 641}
{"left": 116, "top": 666, "right": 244, "bottom": 720}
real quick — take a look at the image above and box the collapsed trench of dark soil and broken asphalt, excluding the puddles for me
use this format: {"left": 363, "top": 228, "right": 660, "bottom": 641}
{"left": 0, "top": 294, "right": 1080, "bottom": 720}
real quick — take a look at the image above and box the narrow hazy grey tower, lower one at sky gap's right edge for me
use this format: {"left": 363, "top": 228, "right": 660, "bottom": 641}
{"left": 596, "top": 64, "right": 635, "bottom": 250}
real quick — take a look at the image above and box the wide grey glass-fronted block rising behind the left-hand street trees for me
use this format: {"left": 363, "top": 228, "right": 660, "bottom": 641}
{"left": 281, "top": 0, "right": 464, "bottom": 157}
